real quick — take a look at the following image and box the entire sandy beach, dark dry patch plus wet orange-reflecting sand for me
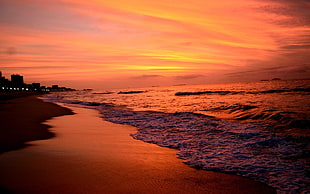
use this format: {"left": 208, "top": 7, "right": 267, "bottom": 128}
{"left": 0, "top": 96, "right": 275, "bottom": 193}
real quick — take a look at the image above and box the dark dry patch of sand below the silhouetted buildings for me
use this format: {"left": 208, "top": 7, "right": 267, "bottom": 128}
{"left": 0, "top": 95, "right": 73, "bottom": 154}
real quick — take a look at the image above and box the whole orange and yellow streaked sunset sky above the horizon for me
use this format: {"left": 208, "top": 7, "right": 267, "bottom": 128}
{"left": 0, "top": 0, "right": 310, "bottom": 89}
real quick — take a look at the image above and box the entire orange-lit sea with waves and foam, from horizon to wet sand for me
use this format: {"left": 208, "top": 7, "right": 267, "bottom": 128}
{"left": 44, "top": 80, "right": 310, "bottom": 193}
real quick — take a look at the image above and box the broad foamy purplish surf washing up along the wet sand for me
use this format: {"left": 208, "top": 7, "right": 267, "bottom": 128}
{"left": 44, "top": 96, "right": 310, "bottom": 193}
